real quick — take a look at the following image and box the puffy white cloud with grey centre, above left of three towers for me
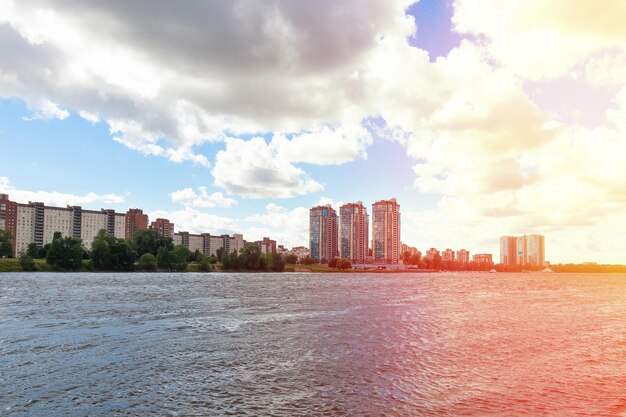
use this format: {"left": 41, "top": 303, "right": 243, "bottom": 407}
{"left": 212, "top": 137, "right": 323, "bottom": 198}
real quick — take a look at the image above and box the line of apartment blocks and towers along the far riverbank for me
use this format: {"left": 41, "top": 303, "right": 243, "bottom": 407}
{"left": 0, "top": 194, "right": 508, "bottom": 264}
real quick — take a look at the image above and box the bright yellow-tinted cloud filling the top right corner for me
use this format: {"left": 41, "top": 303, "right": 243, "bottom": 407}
{"left": 453, "top": 0, "right": 626, "bottom": 80}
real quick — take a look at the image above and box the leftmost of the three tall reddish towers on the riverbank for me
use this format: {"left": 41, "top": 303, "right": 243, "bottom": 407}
{"left": 309, "top": 204, "right": 339, "bottom": 261}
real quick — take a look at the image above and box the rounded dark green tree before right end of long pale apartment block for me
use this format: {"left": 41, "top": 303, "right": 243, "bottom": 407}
{"left": 91, "top": 229, "right": 137, "bottom": 271}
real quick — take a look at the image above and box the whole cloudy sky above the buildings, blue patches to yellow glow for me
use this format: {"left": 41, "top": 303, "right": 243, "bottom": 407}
{"left": 0, "top": 0, "right": 626, "bottom": 263}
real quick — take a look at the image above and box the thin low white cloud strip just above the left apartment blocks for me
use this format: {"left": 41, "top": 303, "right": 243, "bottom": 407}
{"left": 0, "top": 176, "right": 124, "bottom": 207}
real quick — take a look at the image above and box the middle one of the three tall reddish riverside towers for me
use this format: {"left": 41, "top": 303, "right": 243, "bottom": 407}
{"left": 339, "top": 201, "right": 369, "bottom": 263}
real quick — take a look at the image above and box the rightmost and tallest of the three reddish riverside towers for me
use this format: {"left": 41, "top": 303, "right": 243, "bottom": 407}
{"left": 372, "top": 198, "right": 401, "bottom": 264}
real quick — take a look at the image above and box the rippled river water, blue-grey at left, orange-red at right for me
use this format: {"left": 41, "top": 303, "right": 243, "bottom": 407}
{"left": 0, "top": 273, "right": 626, "bottom": 416}
